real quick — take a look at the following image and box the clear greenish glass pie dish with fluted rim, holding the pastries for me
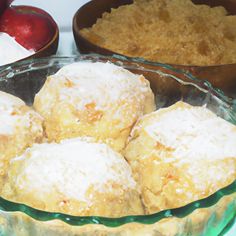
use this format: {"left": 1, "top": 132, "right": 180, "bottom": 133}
{"left": 0, "top": 55, "right": 236, "bottom": 236}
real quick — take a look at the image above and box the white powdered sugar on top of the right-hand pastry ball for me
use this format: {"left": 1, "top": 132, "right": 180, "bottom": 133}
{"left": 145, "top": 102, "right": 236, "bottom": 163}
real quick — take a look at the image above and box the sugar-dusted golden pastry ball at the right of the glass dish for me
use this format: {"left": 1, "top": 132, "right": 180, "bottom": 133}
{"left": 125, "top": 102, "right": 236, "bottom": 213}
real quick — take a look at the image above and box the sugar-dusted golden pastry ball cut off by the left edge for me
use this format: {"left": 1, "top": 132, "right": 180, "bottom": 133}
{"left": 0, "top": 91, "right": 43, "bottom": 173}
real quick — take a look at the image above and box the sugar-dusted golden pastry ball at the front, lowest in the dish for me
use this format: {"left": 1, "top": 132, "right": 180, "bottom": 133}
{"left": 1, "top": 138, "right": 143, "bottom": 216}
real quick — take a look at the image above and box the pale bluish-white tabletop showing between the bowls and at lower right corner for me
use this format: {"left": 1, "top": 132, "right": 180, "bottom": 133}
{"left": 14, "top": 0, "right": 236, "bottom": 236}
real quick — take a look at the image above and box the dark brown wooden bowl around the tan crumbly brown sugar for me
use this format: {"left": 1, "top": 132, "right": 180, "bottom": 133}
{"left": 73, "top": 0, "right": 236, "bottom": 97}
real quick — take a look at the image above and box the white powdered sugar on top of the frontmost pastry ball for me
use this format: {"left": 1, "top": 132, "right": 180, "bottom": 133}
{"left": 11, "top": 138, "right": 136, "bottom": 202}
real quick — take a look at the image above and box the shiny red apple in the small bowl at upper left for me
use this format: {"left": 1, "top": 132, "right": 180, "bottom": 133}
{"left": 0, "top": 5, "right": 56, "bottom": 51}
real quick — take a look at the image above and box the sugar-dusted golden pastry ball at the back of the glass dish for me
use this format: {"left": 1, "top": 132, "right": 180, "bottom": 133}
{"left": 34, "top": 62, "right": 155, "bottom": 151}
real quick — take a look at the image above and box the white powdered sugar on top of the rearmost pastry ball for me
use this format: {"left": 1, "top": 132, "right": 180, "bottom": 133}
{"left": 52, "top": 62, "right": 150, "bottom": 110}
